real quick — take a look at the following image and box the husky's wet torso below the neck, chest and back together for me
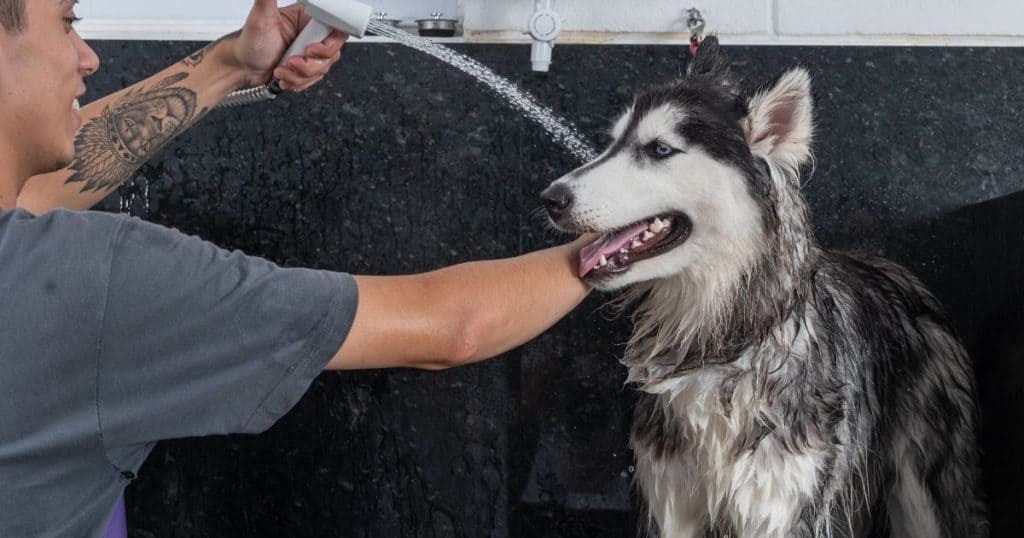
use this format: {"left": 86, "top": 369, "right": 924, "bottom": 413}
{"left": 633, "top": 251, "right": 987, "bottom": 538}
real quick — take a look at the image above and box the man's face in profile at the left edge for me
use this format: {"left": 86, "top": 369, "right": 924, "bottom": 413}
{"left": 0, "top": 0, "right": 99, "bottom": 175}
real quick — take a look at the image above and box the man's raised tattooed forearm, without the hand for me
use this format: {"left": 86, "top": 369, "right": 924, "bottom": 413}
{"left": 18, "top": 34, "right": 245, "bottom": 214}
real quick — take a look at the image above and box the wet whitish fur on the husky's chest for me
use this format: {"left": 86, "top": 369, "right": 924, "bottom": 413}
{"left": 633, "top": 362, "right": 821, "bottom": 536}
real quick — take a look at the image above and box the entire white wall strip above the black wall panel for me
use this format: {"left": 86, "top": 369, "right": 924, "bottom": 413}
{"left": 79, "top": 0, "right": 1024, "bottom": 46}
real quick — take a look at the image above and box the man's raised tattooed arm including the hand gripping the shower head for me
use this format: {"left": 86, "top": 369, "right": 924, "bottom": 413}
{"left": 18, "top": 0, "right": 346, "bottom": 214}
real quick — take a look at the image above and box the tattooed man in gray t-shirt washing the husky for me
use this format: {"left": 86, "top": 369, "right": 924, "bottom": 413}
{"left": 0, "top": 0, "right": 589, "bottom": 537}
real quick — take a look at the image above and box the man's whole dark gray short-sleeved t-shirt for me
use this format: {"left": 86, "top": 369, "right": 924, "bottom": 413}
{"left": 0, "top": 210, "right": 357, "bottom": 537}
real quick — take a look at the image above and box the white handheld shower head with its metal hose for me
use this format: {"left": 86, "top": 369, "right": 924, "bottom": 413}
{"left": 217, "top": 0, "right": 371, "bottom": 109}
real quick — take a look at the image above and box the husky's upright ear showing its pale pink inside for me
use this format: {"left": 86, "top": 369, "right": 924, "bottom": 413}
{"left": 743, "top": 68, "right": 814, "bottom": 169}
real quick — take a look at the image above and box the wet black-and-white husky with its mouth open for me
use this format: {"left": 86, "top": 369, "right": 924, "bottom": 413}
{"left": 543, "top": 37, "right": 988, "bottom": 538}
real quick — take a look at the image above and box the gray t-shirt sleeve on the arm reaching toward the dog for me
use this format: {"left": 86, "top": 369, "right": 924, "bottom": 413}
{"left": 97, "top": 215, "right": 357, "bottom": 450}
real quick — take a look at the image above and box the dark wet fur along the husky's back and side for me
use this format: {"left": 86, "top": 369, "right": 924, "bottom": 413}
{"left": 815, "top": 253, "right": 987, "bottom": 537}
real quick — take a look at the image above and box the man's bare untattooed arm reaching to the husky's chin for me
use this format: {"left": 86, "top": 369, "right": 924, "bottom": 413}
{"left": 328, "top": 237, "right": 593, "bottom": 370}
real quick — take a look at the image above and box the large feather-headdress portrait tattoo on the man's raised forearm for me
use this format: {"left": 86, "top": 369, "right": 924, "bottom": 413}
{"left": 68, "top": 73, "right": 209, "bottom": 193}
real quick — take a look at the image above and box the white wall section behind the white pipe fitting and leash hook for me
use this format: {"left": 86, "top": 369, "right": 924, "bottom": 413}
{"left": 464, "top": 0, "right": 1024, "bottom": 46}
